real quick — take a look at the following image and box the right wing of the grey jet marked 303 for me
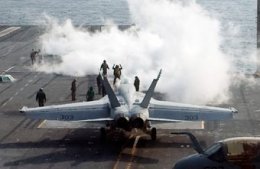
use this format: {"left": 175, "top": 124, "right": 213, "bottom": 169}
{"left": 149, "top": 99, "right": 237, "bottom": 122}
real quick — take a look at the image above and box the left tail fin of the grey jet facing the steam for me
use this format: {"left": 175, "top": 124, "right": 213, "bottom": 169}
{"left": 102, "top": 77, "right": 120, "bottom": 108}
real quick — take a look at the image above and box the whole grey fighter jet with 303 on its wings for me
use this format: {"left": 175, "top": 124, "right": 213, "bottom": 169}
{"left": 20, "top": 70, "right": 237, "bottom": 140}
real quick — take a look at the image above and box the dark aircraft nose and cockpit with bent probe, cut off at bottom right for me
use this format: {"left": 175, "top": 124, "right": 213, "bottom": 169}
{"left": 172, "top": 132, "right": 260, "bottom": 169}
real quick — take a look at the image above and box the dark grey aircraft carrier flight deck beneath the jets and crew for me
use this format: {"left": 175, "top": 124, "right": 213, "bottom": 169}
{"left": 0, "top": 26, "right": 260, "bottom": 169}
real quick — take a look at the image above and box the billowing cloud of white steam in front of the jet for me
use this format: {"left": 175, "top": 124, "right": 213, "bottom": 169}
{"left": 35, "top": 0, "right": 235, "bottom": 104}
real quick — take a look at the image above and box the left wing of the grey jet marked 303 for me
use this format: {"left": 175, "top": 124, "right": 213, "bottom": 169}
{"left": 20, "top": 100, "right": 113, "bottom": 122}
